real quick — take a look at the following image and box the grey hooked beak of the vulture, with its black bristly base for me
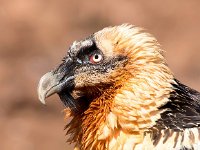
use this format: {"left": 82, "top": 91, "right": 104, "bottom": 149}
{"left": 37, "top": 58, "right": 74, "bottom": 104}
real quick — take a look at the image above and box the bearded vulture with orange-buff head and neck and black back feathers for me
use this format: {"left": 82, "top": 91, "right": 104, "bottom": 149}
{"left": 38, "top": 25, "right": 200, "bottom": 150}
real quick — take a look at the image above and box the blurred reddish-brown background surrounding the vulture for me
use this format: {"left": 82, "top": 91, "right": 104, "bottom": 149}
{"left": 0, "top": 0, "right": 200, "bottom": 150}
